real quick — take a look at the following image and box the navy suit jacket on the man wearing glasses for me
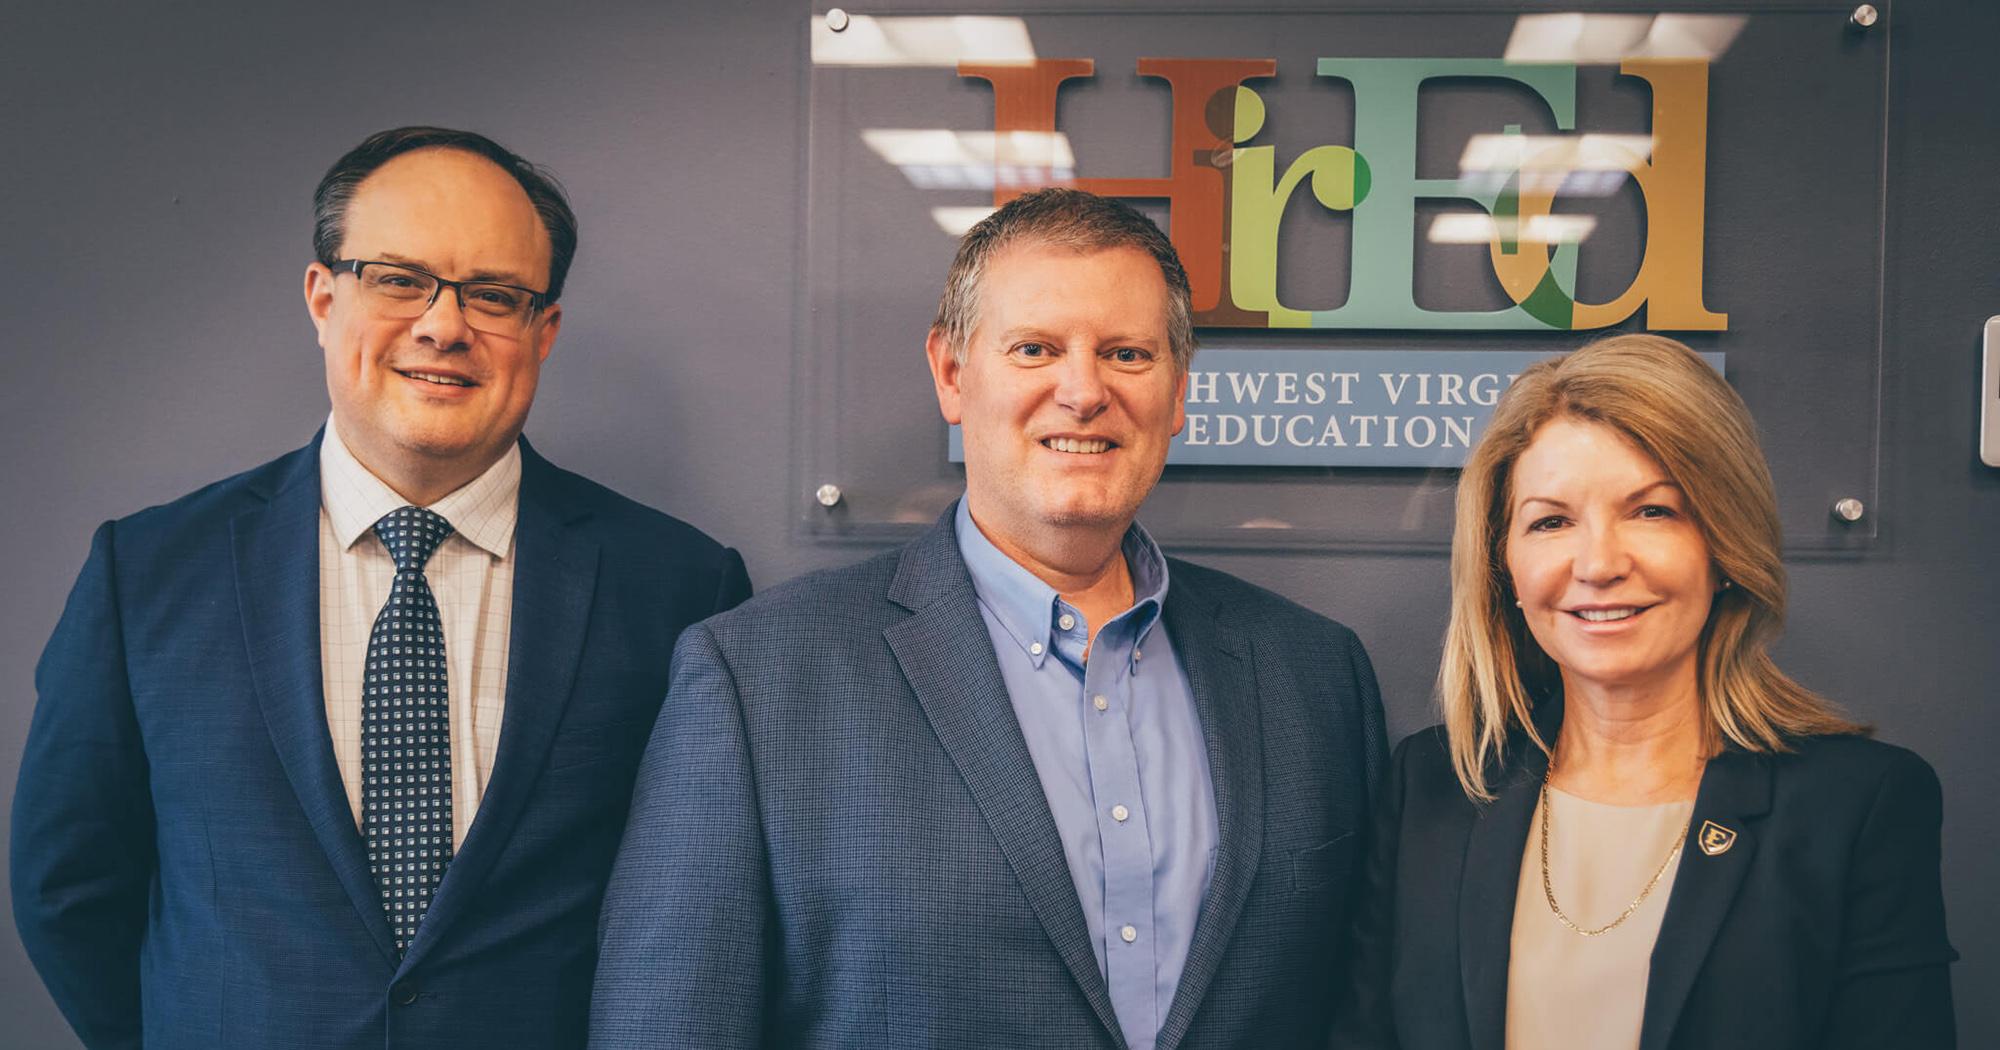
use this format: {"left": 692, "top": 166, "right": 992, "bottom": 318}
{"left": 12, "top": 440, "right": 748, "bottom": 1050}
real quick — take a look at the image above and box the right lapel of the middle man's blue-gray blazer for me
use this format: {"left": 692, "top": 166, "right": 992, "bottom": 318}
{"left": 1158, "top": 574, "right": 1264, "bottom": 1050}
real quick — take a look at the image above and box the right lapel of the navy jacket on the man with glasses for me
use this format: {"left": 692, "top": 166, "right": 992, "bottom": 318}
{"left": 404, "top": 440, "right": 598, "bottom": 966}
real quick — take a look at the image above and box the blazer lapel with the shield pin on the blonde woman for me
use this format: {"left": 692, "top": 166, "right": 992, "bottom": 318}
{"left": 1638, "top": 748, "right": 1770, "bottom": 1050}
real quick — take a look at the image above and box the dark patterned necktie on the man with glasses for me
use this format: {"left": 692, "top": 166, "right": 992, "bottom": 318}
{"left": 362, "top": 506, "right": 452, "bottom": 952}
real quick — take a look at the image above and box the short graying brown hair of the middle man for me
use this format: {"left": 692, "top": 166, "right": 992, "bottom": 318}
{"left": 932, "top": 186, "right": 1194, "bottom": 372}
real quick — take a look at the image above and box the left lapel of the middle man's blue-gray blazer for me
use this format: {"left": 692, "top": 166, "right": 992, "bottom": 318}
{"left": 882, "top": 512, "right": 1124, "bottom": 1048}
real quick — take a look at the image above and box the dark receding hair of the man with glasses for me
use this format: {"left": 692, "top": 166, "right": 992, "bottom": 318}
{"left": 312, "top": 126, "right": 576, "bottom": 302}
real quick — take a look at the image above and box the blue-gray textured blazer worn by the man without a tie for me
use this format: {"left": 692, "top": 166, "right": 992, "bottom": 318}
{"left": 590, "top": 514, "right": 1386, "bottom": 1050}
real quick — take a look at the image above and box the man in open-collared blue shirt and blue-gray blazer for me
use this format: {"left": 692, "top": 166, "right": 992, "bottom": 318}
{"left": 592, "top": 190, "right": 1384, "bottom": 1050}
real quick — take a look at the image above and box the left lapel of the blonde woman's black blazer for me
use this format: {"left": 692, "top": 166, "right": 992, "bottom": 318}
{"left": 1458, "top": 748, "right": 1554, "bottom": 1050}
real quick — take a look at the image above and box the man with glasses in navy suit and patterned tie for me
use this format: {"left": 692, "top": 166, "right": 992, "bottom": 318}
{"left": 12, "top": 128, "right": 748, "bottom": 1050}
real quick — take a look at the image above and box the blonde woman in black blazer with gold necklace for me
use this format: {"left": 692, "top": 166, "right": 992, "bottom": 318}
{"left": 1334, "top": 336, "right": 1956, "bottom": 1050}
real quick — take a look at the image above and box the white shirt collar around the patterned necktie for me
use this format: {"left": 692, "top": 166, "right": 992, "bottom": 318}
{"left": 320, "top": 416, "right": 520, "bottom": 558}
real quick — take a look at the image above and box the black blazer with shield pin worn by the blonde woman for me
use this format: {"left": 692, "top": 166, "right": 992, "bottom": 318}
{"left": 1332, "top": 716, "right": 1958, "bottom": 1050}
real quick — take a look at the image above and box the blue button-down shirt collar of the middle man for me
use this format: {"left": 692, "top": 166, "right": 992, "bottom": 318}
{"left": 954, "top": 498, "right": 1166, "bottom": 666}
